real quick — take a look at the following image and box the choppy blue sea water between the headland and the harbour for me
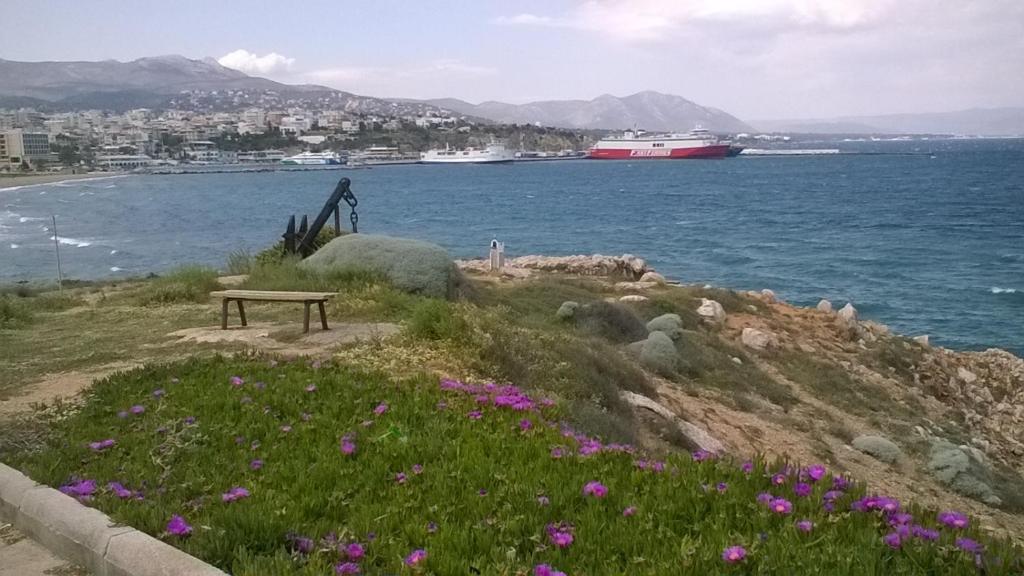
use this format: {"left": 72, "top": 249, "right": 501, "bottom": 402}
{"left": 0, "top": 139, "right": 1024, "bottom": 355}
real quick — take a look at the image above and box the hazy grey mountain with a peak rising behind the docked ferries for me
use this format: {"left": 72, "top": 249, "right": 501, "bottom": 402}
{"left": 413, "top": 90, "right": 753, "bottom": 132}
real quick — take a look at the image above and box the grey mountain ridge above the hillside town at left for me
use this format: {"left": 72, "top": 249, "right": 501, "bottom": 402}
{"left": 0, "top": 55, "right": 448, "bottom": 114}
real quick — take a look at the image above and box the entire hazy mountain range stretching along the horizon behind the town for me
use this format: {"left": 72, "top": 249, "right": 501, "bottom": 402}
{"left": 0, "top": 55, "right": 1024, "bottom": 135}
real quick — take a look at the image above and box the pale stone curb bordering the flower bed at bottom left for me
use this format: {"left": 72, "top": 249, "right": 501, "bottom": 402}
{"left": 0, "top": 463, "right": 226, "bottom": 576}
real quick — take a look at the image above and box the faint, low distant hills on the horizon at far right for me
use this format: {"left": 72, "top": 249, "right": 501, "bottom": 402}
{"left": 753, "top": 108, "right": 1024, "bottom": 136}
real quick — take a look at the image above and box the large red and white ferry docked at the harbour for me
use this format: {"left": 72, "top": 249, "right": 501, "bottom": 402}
{"left": 588, "top": 128, "right": 729, "bottom": 160}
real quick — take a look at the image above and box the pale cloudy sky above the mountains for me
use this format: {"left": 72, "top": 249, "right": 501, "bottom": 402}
{"left": 0, "top": 0, "right": 1024, "bottom": 120}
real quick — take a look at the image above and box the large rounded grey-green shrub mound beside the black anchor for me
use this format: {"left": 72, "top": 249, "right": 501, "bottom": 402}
{"left": 300, "top": 234, "right": 462, "bottom": 298}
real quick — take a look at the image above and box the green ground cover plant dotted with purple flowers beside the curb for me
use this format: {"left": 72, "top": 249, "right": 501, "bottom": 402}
{"left": 17, "top": 357, "right": 1024, "bottom": 576}
